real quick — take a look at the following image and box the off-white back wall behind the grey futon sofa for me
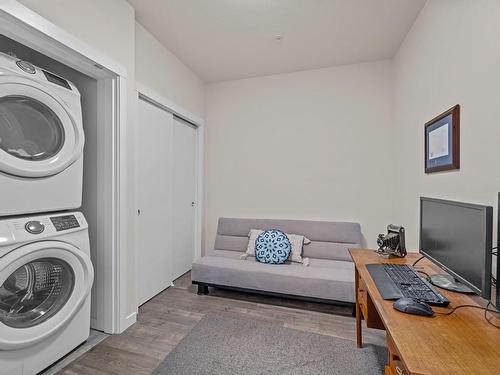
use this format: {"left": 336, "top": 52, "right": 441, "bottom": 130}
{"left": 205, "top": 61, "right": 394, "bottom": 254}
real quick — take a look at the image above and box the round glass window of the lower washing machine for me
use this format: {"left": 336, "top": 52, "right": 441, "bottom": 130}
{"left": 0, "top": 258, "right": 75, "bottom": 328}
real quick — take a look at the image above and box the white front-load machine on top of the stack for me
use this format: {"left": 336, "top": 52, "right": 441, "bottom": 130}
{"left": 0, "top": 53, "right": 85, "bottom": 216}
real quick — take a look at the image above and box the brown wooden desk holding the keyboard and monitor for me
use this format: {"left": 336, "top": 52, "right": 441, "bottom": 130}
{"left": 349, "top": 249, "right": 500, "bottom": 375}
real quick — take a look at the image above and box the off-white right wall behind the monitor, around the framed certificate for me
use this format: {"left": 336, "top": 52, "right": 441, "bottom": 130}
{"left": 394, "top": 0, "right": 500, "bottom": 253}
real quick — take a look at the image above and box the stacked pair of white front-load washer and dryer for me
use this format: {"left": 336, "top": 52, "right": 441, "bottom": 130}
{"left": 0, "top": 54, "right": 94, "bottom": 375}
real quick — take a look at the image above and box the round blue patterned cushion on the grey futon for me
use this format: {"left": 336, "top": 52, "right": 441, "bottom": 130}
{"left": 255, "top": 229, "right": 292, "bottom": 264}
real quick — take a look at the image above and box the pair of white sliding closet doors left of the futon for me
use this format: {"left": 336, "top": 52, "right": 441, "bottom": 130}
{"left": 136, "top": 94, "right": 199, "bottom": 305}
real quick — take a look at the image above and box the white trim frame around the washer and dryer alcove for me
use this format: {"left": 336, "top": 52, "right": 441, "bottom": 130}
{"left": 0, "top": 0, "right": 131, "bottom": 333}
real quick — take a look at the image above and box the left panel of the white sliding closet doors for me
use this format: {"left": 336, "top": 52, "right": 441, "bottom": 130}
{"left": 136, "top": 100, "right": 173, "bottom": 305}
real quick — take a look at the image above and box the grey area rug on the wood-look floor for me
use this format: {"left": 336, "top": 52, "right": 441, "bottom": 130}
{"left": 153, "top": 315, "right": 387, "bottom": 375}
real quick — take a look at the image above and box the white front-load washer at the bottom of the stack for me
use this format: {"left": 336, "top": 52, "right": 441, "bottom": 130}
{"left": 0, "top": 212, "right": 94, "bottom": 375}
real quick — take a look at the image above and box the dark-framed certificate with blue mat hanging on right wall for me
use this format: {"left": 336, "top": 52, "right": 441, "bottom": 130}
{"left": 425, "top": 104, "right": 460, "bottom": 173}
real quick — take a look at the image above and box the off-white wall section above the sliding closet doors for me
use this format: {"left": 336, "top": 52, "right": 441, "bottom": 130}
{"left": 135, "top": 22, "right": 205, "bottom": 118}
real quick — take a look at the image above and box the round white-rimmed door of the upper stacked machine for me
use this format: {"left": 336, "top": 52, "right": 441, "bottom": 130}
{"left": 0, "top": 75, "right": 84, "bottom": 178}
